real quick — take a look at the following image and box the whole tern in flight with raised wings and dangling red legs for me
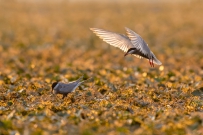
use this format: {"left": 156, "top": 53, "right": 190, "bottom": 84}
{"left": 90, "top": 28, "right": 162, "bottom": 67}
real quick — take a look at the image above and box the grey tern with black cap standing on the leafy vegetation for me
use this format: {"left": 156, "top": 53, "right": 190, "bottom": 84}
{"left": 51, "top": 76, "right": 84, "bottom": 99}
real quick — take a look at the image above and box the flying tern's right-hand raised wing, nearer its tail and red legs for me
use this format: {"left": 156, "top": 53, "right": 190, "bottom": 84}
{"left": 125, "top": 28, "right": 151, "bottom": 57}
